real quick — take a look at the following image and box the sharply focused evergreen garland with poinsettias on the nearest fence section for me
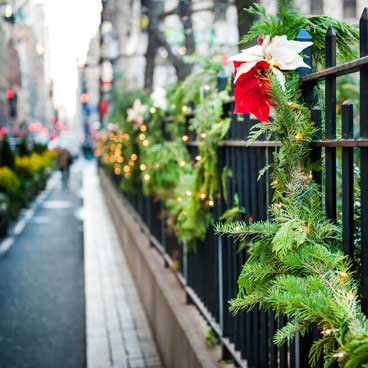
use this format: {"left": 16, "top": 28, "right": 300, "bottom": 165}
{"left": 216, "top": 5, "right": 368, "bottom": 368}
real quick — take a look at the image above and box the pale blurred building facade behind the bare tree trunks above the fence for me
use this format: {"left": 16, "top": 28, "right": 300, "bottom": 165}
{"left": 84, "top": 0, "right": 368, "bottom": 111}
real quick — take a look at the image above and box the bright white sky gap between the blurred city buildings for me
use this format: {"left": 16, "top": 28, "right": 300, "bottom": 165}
{"left": 33, "top": 0, "right": 101, "bottom": 116}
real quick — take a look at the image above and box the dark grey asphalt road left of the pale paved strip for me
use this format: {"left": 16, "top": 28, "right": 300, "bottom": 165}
{"left": 0, "top": 163, "right": 85, "bottom": 368}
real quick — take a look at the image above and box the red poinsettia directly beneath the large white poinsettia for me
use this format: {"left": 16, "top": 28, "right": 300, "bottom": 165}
{"left": 234, "top": 61, "right": 272, "bottom": 122}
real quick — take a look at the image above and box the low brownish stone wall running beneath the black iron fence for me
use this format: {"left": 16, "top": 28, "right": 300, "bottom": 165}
{"left": 99, "top": 170, "right": 220, "bottom": 368}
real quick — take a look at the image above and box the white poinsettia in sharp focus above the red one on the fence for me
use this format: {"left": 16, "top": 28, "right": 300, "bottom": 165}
{"left": 229, "top": 36, "right": 313, "bottom": 88}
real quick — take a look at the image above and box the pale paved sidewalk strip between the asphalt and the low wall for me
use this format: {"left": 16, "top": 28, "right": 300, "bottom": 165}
{"left": 83, "top": 163, "right": 162, "bottom": 368}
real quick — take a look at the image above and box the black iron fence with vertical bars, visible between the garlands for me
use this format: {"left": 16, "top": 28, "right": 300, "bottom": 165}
{"left": 104, "top": 9, "right": 368, "bottom": 368}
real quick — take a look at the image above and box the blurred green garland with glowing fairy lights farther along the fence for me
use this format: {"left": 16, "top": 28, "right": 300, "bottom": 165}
{"left": 97, "top": 58, "right": 230, "bottom": 248}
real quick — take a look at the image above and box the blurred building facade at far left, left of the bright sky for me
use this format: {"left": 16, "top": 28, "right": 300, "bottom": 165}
{"left": 0, "top": 0, "right": 51, "bottom": 131}
